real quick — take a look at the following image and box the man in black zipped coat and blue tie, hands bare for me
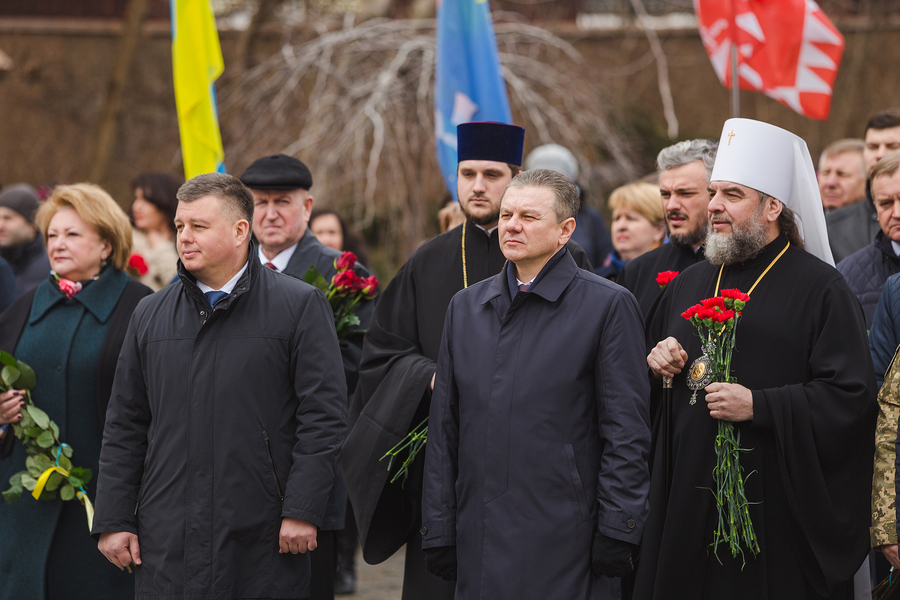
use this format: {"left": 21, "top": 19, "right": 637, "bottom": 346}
{"left": 92, "top": 173, "right": 346, "bottom": 598}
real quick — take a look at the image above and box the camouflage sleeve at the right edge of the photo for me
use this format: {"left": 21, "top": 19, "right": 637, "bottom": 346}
{"left": 870, "top": 350, "right": 900, "bottom": 548}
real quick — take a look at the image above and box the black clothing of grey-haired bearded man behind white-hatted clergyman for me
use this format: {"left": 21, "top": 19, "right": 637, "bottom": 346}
{"left": 616, "top": 242, "right": 706, "bottom": 319}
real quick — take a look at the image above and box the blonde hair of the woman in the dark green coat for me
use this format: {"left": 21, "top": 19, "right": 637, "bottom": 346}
{"left": 35, "top": 183, "right": 131, "bottom": 271}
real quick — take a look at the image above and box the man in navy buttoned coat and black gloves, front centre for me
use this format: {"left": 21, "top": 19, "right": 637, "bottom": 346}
{"left": 422, "top": 169, "right": 650, "bottom": 600}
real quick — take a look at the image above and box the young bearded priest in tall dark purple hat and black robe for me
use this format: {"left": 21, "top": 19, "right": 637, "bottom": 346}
{"left": 341, "top": 123, "right": 589, "bottom": 600}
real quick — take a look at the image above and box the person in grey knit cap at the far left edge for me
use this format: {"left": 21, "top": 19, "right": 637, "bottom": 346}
{"left": 0, "top": 183, "right": 50, "bottom": 294}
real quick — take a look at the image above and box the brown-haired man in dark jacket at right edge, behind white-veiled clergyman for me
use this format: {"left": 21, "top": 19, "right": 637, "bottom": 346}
{"left": 837, "top": 152, "right": 900, "bottom": 328}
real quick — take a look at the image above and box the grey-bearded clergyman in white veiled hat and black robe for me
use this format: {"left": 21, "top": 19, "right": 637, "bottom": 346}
{"left": 634, "top": 119, "right": 877, "bottom": 600}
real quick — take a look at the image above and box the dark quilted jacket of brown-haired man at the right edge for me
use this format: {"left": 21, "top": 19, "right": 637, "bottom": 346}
{"left": 837, "top": 232, "right": 900, "bottom": 329}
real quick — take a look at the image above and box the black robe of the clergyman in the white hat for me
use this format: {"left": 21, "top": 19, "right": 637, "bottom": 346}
{"left": 634, "top": 237, "right": 877, "bottom": 600}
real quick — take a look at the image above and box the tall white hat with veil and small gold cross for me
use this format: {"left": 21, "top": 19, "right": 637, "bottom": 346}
{"left": 709, "top": 119, "right": 834, "bottom": 266}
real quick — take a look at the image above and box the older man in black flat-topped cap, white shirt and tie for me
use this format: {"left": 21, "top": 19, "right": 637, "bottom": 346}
{"left": 241, "top": 154, "right": 372, "bottom": 600}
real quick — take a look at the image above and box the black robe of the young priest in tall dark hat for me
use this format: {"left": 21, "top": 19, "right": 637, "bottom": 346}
{"left": 340, "top": 222, "right": 591, "bottom": 584}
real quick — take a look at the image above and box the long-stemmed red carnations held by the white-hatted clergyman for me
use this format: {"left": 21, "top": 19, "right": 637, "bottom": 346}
{"left": 681, "top": 289, "right": 759, "bottom": 558}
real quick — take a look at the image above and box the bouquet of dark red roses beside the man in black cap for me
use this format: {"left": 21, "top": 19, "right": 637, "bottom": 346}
{"left": 303, "top": 252, "right": 378, "bottom": 340}
